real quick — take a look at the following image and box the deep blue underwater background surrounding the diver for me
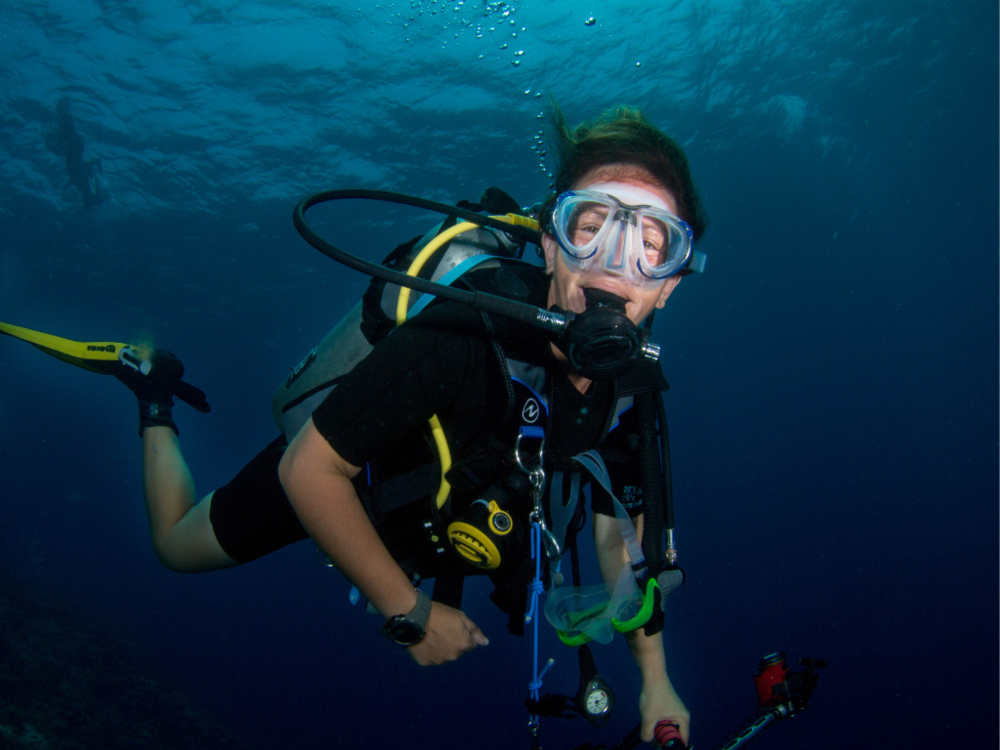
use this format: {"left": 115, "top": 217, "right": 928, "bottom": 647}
{"left": 0, "top": 0, "right": 998, "bottom": 750}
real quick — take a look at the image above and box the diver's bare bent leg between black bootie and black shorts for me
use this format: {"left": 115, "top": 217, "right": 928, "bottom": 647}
{"left": 142, "top": 426, "right": 239, "bottom": 573}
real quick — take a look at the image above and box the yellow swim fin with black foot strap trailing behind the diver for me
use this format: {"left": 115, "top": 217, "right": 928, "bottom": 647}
{"left": 0, "top": 322, "right": 211, "bottom": 412}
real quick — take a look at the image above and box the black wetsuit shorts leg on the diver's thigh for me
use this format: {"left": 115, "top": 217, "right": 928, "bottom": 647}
{"left": 208, "top": 435, "right": 309, "bottom": 563}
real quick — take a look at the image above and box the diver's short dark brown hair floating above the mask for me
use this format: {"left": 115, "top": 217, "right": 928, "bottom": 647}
{"left": 540, "top": 101, "right": 708, "bottom": 240}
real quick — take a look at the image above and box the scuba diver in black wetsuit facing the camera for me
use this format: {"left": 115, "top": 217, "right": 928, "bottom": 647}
{"left": 7, "top": 106, "right": 707, "bottom": 746}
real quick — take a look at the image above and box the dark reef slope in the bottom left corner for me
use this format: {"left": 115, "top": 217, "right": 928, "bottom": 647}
{"left": 0, "top": 568, "right": 248, "bottom": 750}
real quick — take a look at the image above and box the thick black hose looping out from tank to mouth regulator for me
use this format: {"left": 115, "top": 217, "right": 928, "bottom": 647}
{"left": 292, "top": 190, "right": 571, "bottom": 333}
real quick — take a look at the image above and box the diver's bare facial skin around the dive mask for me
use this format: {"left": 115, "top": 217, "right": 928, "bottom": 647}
{"left": 542, "top": 165, "right": 680, "bottom": 325}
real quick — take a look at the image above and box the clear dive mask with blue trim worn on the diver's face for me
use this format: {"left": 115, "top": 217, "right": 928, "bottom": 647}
{"left": 552, "top": 182, "right": 694, "bottom": 284}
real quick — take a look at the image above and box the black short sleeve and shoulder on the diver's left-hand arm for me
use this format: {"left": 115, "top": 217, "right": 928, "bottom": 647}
{"left": 312, "top": 302, "right": 502, "bottom": 466}
